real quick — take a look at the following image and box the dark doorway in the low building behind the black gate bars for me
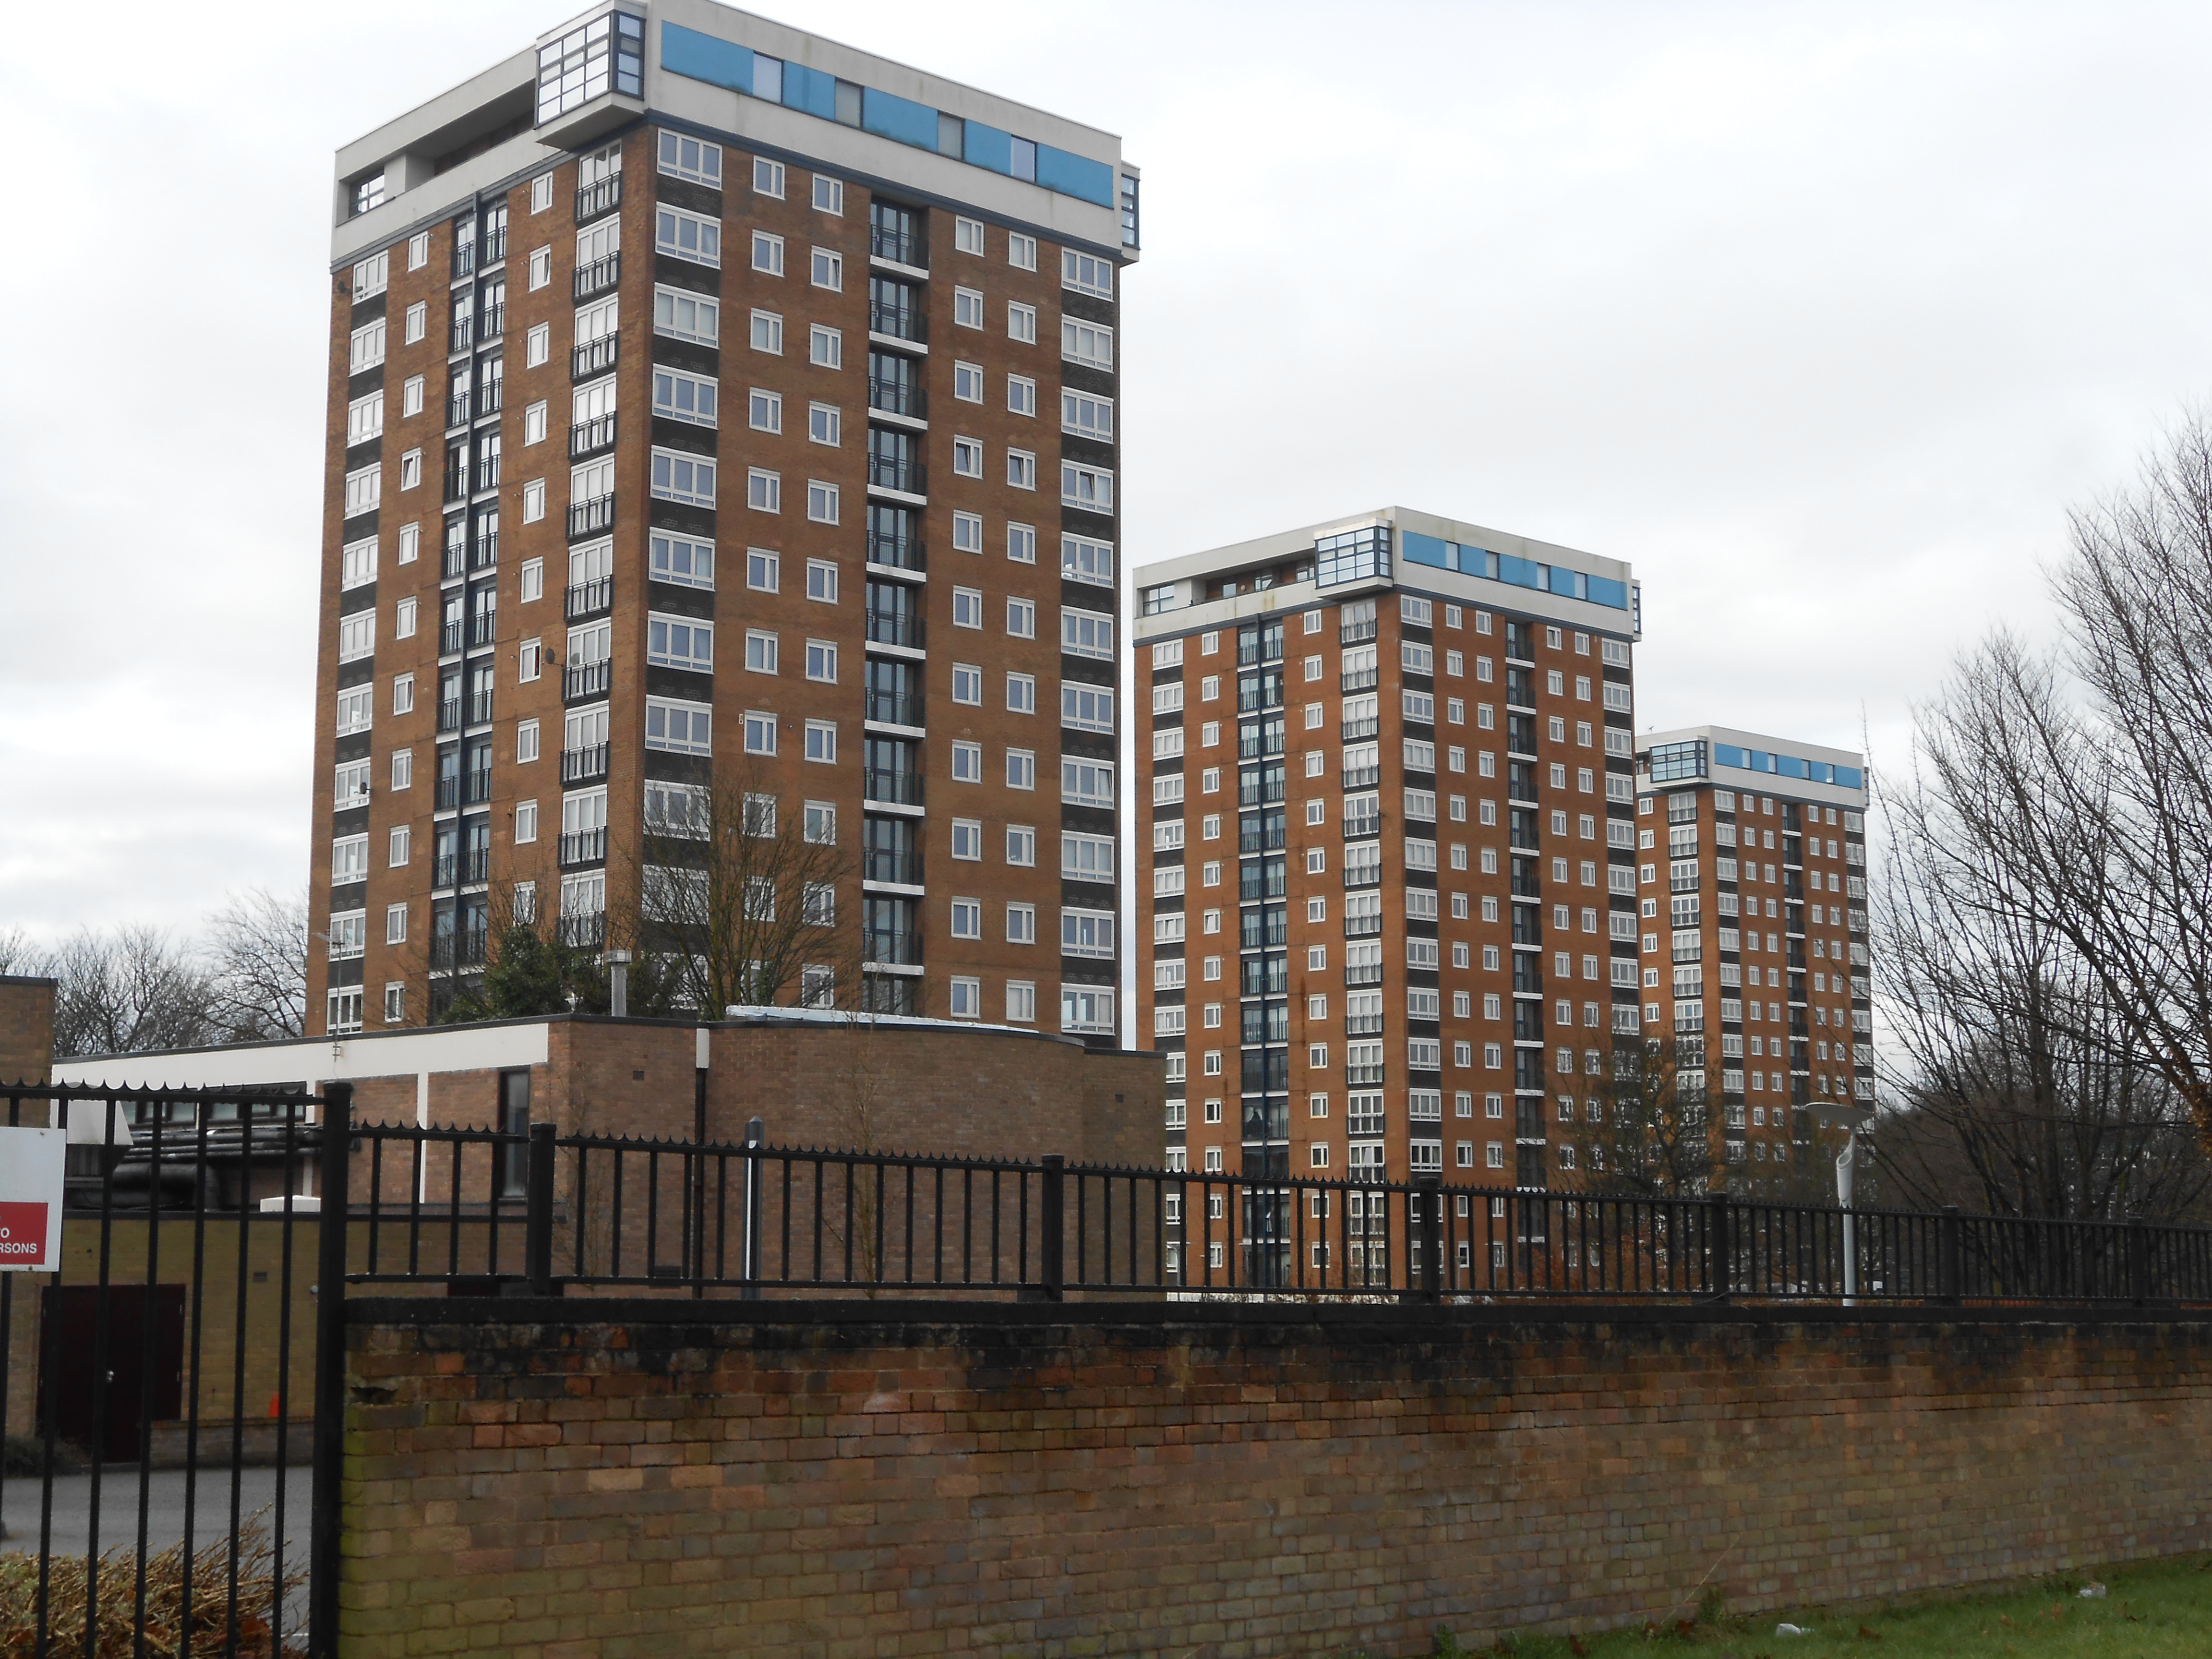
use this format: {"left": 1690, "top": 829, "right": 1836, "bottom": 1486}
{"left": 40, "top": 1285, "right": 183, "bottom": 1462}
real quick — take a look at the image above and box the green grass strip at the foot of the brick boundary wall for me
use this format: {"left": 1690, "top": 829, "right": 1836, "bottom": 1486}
{"left": 1436, "top": 1555, "right": 2212, "bottom": 1659}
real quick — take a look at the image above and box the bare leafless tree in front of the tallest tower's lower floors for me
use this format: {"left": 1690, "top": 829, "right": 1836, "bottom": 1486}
{"left": 628, "top": 765, "right": 865, "bottom": 1013}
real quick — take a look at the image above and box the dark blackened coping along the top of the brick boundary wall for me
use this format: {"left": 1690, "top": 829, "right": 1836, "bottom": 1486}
{"left": 345, "top": 1296, "right": 2212, "bottom": 1340}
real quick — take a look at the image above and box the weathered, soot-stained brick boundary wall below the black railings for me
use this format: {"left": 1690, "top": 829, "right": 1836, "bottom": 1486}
{"left": 343, "top": 1301, "right": 2212, "bottom": 1659}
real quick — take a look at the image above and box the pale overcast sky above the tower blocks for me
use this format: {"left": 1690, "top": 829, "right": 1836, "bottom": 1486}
{"left": 0, "top": 0, "right": 2212, "bottom": 936}
